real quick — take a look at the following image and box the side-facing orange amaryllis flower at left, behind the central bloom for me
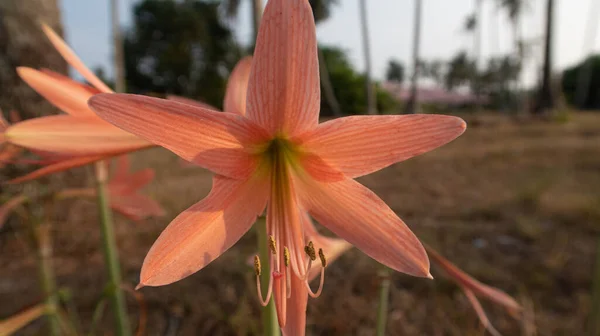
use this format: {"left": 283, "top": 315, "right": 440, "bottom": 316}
{"left": 3, "top": 25, "right": 152, "bottom": 183}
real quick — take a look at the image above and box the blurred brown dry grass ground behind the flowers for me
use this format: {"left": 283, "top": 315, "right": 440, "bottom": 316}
{"left": 0, "top": 114, "right": 600, "bottom": 335}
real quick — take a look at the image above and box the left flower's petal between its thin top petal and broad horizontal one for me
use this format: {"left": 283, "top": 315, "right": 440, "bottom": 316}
{"left": 17, "top": 67, "right": 97, "bottom": 118}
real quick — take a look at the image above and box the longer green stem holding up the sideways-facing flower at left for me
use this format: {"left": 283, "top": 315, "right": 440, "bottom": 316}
{"left": 96, "top": 162, "right": 131, "bottom": 336}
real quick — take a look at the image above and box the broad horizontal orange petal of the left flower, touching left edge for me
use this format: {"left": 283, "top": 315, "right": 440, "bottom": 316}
{"left": 5, "top": 115, "right": 152, "bottom": 155}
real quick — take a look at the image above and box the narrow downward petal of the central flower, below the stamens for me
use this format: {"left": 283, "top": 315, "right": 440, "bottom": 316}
{"left": 281, "top": 274, "right": 308, "bottom": 336}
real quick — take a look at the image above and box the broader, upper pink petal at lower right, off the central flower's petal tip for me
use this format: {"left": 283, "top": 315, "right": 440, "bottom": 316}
{"left": 426, "top": 246, "right": 521, "bottom": 313}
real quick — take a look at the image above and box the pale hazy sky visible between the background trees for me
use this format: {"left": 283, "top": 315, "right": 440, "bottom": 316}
{"left": 61, "top": 0, "right": 599, "bottom": 85}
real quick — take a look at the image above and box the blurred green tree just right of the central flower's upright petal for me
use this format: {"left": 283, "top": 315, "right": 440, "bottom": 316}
{"left": 320, "top": 46, "right": 398, "bottom": 115}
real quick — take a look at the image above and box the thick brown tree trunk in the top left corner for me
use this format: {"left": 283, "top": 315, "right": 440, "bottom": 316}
{"left": 0, "top": 0, "right": 67, "bottom": 119}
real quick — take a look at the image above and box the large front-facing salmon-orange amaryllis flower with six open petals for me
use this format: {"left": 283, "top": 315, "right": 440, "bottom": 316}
{"left": 89, "top": 0, "right": 465, "bottom": 334}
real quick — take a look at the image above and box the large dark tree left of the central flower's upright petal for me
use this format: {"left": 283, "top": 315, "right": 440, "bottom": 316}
{"left": 125, "top": 0, "right": 241, "bottom": 106}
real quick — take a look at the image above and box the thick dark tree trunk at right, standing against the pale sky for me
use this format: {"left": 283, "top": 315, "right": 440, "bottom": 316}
{"left": 533, "top": 0, "right": 554, "bottom": 115}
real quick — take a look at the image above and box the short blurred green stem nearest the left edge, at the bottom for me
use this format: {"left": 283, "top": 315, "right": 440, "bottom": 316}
{"left": 34, "top": 222, "right": 60, "bottom": 336}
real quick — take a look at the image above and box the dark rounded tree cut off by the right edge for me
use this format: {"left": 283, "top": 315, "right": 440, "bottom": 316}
{"left": 561, "top": 55, "right": 600, "bottom": 109}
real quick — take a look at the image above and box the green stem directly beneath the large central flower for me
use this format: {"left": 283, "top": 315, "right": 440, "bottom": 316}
{"left": 256, "top": 217, "right": 280, "bottom": 336}
